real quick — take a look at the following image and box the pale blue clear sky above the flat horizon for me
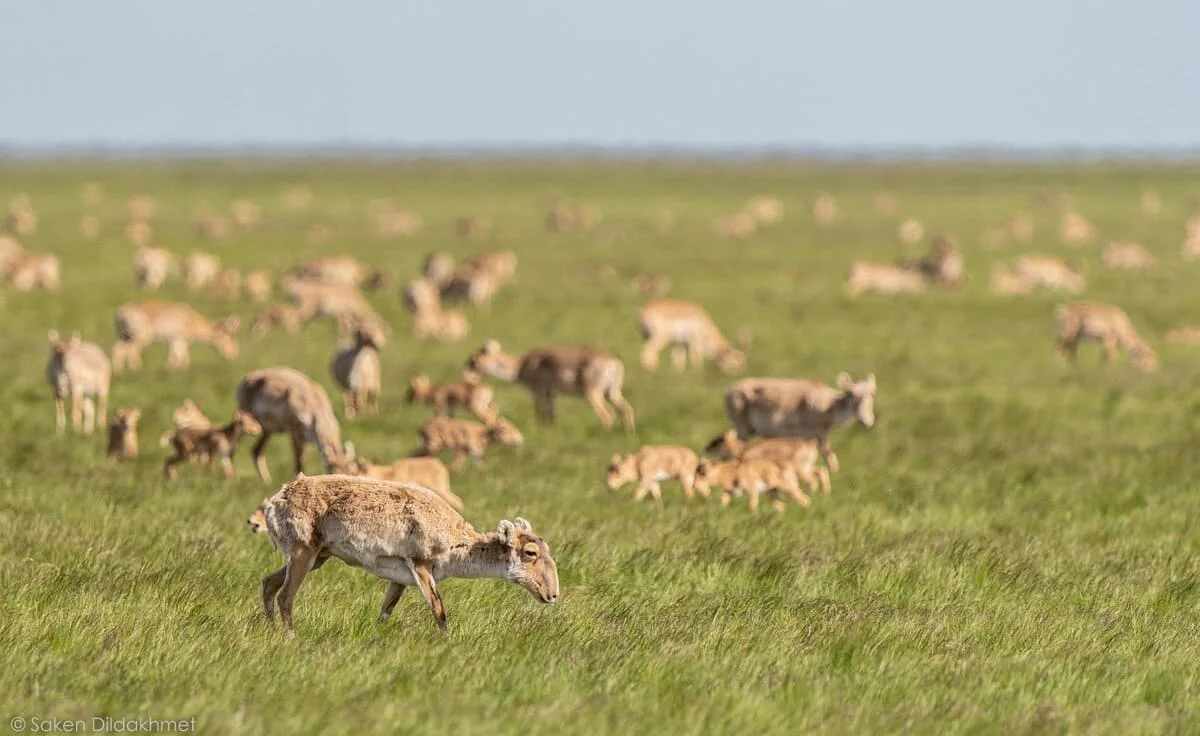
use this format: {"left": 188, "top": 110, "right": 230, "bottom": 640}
{"left": 0, "top": 0, "right": 1200, "bottom": 148}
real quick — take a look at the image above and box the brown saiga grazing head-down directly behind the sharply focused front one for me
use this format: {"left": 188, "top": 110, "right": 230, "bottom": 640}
{"left": 236, "top": 367, "right": 354, "bottom": 483}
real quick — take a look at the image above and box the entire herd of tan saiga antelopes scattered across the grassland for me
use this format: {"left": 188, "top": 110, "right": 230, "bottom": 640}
{"left": 14, "top": 181, "right": 1185, "bottom": 629}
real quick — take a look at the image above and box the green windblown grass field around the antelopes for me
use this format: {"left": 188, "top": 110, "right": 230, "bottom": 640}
{"left": 0, "top": 161, "right": 1200, "bottom": 734}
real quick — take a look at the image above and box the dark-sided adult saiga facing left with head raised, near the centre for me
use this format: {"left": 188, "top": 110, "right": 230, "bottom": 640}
{"left": 467, "top": 340, "right": 634, "bottom": 431}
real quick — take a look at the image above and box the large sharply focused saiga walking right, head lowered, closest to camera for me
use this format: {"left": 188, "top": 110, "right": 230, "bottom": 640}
{"left": 252, "top": 473, "right": 558, "bottom": 632}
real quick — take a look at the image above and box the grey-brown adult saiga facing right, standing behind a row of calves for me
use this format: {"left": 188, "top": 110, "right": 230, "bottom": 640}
{"left": 725, "top": 373, "right": 876, "bottom": 473}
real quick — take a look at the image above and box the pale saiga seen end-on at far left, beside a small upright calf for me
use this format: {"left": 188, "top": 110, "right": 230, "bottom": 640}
{"left": 46, "top": 330, "right": 113, "bottom": 435}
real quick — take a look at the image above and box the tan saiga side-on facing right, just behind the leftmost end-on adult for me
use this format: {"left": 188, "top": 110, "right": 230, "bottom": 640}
{"left": 113, "top": 300, "right": 241, "bottom": 372}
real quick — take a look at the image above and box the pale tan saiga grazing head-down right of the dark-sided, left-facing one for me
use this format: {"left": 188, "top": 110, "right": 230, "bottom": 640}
{"left": 637, "top": 299, "right": 746, "bottom": 373}
